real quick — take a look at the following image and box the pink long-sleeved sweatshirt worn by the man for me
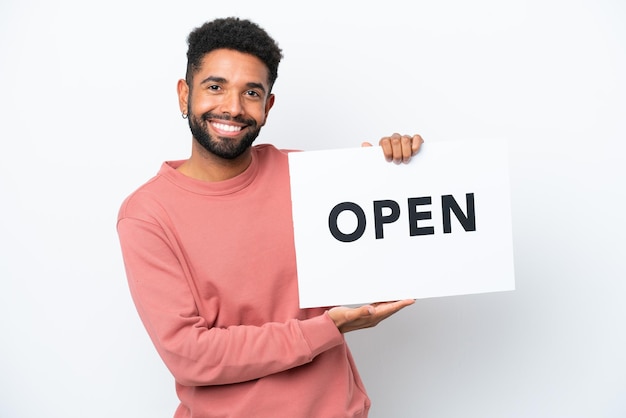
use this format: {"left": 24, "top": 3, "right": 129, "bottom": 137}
{"left": 117, "top": 145, "right": 370, "bottom": 418}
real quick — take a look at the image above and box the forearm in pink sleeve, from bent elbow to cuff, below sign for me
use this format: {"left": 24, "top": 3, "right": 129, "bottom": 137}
{"left": 141, "top": 315, "right": 343, "bottom": 386}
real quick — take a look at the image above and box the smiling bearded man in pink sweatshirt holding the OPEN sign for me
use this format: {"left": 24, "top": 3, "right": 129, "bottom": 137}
{"left": 117, "top": 18, "right": 422, "bottom": 418}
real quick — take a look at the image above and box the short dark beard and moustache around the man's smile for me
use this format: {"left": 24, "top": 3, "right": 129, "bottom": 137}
{"left": 188, "top": 109, "right": 261, "bottom": 160}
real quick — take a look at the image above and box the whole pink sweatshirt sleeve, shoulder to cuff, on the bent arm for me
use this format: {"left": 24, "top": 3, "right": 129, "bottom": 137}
{"left": 117, "top": 215, "right": 344, "bottom": 386}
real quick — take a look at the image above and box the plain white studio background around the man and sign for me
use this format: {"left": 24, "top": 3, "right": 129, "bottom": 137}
{"left": 0, "top": 0, "right": 626, "bottom": 418}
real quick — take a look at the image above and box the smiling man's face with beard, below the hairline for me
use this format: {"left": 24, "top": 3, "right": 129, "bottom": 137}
{"left": 179, "top": 49, "right": 274, "bottom": 160}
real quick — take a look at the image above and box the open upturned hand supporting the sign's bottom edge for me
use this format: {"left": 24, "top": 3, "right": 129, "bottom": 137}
{"left": 328, "top": 299, "right": 415, "bottom": 333}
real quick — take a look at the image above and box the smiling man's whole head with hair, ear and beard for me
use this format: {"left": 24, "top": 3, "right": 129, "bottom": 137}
{"left": 178, "top": 18, "right": 282, "bottom": 160}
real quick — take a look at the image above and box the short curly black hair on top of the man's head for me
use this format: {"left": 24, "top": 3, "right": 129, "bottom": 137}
{"left": 185, "top": 17, "right": 283, "bottom": 90}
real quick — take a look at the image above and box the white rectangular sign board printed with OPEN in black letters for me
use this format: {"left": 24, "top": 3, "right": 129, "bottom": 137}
{"left": 289, "top": 140, "right": 515, "bottom": 308}
